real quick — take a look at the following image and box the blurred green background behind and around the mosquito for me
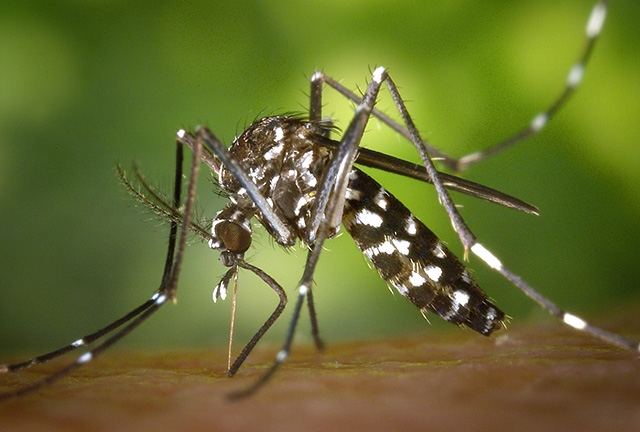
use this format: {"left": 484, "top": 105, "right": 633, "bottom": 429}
{"left": 0, "top": 0, "right": 640, "bottom": 363}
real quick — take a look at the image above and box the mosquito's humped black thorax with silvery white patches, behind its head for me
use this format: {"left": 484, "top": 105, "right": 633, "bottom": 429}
{"left": 218, "top": 116, "right": 338, "bottom": 247}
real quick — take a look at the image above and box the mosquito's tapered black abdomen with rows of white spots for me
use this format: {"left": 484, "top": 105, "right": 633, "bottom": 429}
{"left": 342, "top": 168, "right": 504, "bottom": 335}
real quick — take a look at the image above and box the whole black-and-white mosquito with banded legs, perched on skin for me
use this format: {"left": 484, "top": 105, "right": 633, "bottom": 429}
{"left": 0, "top": 1, "right": 640, "bottom": 398}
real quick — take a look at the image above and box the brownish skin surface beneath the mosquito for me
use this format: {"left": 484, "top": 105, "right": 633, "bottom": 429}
{"left": 0, "top": 321, "right": 640, "bottom": 431}
